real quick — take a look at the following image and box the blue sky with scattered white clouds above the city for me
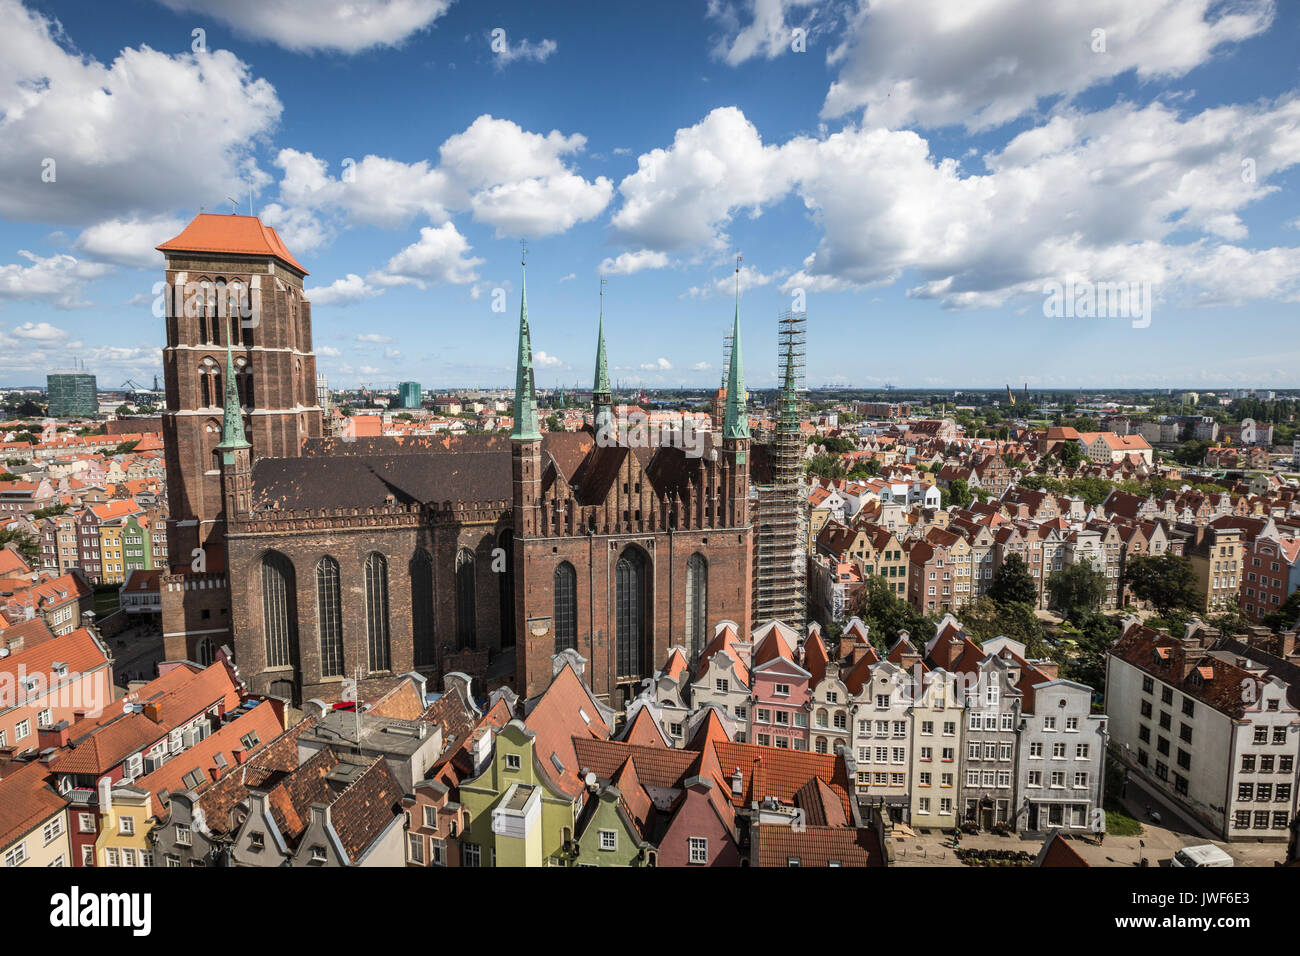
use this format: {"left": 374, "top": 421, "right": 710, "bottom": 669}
{"left": 0, "top": 0, "right": 1300, "bottom": 388}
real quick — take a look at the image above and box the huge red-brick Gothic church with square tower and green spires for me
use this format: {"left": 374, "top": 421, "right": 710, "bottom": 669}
{"left": 159, "top": 215, "right": 753, "bottom": 708}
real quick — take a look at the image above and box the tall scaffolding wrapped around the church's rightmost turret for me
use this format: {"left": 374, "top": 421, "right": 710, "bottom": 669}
{"left": 754, "top": 312, "right": 809, "bottom": 633}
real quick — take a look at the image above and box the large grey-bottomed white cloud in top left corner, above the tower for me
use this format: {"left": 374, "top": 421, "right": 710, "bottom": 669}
{"left": 0, "top": 0, "right": 281, "bottom": 225}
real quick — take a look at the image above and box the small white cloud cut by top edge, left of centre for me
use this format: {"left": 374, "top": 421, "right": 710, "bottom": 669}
{"left": 159, "top": 0, "right": 451, "bottom": 53}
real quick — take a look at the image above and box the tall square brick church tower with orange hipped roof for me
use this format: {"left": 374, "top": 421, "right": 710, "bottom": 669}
{"left": 155, "top": 213, "right": 321, "bottom": 663}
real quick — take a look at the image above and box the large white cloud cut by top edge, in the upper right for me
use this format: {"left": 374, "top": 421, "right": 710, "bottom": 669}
{"left": 822, "top": 0, "right": 1274, "bottom": 129}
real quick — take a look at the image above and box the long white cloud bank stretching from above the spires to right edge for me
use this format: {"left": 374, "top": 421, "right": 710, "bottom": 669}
{"left": 614, "top": 95, "right": 1300, "bottom": 308}
